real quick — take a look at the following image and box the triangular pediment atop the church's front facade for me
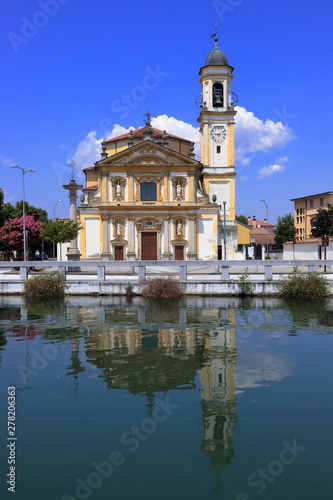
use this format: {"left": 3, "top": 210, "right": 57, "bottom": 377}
{"left": 95, "top": 140, "right": 201, "bottom": 168}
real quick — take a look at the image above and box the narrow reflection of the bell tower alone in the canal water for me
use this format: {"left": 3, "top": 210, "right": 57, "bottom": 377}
{"left": 200, "top": 327, "right": 236, "bottom": 471}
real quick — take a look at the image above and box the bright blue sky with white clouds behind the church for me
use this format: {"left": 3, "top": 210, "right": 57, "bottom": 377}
{"left": 0, "top": 0, "right": 333, "bottom": 222}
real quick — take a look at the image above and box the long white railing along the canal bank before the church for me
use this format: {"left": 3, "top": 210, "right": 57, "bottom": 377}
{"left": 0, "top": 260, "right": 333, "bottom": 281}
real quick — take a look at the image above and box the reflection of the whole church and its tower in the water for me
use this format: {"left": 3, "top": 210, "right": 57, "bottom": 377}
{"left": 70, "top": 302, "right": 236, "bottom": 471}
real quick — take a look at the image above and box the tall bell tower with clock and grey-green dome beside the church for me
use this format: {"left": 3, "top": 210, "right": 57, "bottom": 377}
{"left": 198, "top": 33, "right": 236, "bottom": 220}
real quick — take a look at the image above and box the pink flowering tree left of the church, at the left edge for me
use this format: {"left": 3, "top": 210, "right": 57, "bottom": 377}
{"left": 0, "top": 215, "right": 42, "bottom": 258}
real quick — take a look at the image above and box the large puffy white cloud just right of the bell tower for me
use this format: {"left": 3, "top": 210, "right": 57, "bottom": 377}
{"left": 235, "top": 106, "right": 296, "bottom": 166}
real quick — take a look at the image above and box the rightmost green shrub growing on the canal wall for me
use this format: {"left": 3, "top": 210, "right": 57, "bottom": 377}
{"left": 279, "top": 268, "right": 329, "bottom": 299}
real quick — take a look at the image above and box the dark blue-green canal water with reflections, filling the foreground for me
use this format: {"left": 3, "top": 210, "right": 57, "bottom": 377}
{"left": 0, "top": 297, "right": 333, "bottom": 500}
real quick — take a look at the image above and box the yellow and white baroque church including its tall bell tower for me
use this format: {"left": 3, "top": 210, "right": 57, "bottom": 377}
{"left": 78, "top": 38, "right": 245, "bottom": 260}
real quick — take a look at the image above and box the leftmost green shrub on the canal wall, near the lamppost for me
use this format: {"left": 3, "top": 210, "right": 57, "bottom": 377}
{"left": 23, "top": 273, "right": 65, "bottom": 299}
